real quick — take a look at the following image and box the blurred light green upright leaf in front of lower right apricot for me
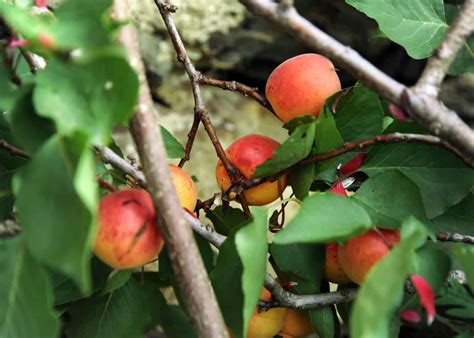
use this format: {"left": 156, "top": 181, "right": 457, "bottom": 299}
{"left": 350, "top": 218, "right": 427, "bottom": 338}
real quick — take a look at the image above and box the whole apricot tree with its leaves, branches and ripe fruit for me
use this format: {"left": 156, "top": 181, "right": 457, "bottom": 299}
{"left": 0, "top": 0, "right": 474, "bottom": 338}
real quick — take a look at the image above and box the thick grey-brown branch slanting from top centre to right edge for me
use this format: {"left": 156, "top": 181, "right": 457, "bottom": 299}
{"left": 240, "top": 0, "right": 474, "bottom": 166}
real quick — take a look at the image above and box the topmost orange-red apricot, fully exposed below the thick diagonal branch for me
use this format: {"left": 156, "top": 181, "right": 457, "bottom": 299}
{"left": 265, "top": 54, "right": 341, "bottom": 122}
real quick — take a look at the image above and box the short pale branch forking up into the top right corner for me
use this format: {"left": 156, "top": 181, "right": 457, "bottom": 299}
{"left": 416, "top": 0, "right": 474, "bottom": 96}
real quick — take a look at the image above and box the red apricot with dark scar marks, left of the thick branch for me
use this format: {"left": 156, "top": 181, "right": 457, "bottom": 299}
{"left": 94, "top": 189, "right": 164, "bottom": 269}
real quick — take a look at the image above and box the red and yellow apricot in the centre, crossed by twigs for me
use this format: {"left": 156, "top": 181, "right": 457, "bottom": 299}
{"left": 216, "top": 135, "right": 286, "bottom": 205}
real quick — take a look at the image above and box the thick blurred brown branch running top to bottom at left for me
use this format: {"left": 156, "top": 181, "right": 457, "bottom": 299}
{"left": 115, "top": 0, "right": 228, "bottom": 338}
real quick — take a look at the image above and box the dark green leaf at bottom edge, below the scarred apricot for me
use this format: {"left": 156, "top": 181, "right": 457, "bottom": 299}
{"left": 65, "top": 274, "right": 166, "bottom": 338}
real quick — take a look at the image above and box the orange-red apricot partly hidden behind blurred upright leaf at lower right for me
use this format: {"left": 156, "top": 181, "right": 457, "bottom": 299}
{"left": 337, "top": 229, "right": 400, "bottom": 284}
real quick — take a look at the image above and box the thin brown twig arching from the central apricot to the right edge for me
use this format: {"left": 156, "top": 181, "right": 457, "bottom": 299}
{"left": 227, "top": 133, "right": 474, "bottom": 198}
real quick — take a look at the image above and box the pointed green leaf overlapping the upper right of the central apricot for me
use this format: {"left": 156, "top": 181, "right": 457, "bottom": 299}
{"left": 253, "top": 122, "right": 315, "bottom": 178}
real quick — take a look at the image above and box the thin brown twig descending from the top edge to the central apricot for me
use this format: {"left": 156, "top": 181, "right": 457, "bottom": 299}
{"left": 155, "top": 0, "right": 251, "bottom": 218}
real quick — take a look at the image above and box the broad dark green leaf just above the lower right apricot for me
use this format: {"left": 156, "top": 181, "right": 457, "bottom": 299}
{"left": 352, "top": 170, "right": 430, "bottom": 228}
